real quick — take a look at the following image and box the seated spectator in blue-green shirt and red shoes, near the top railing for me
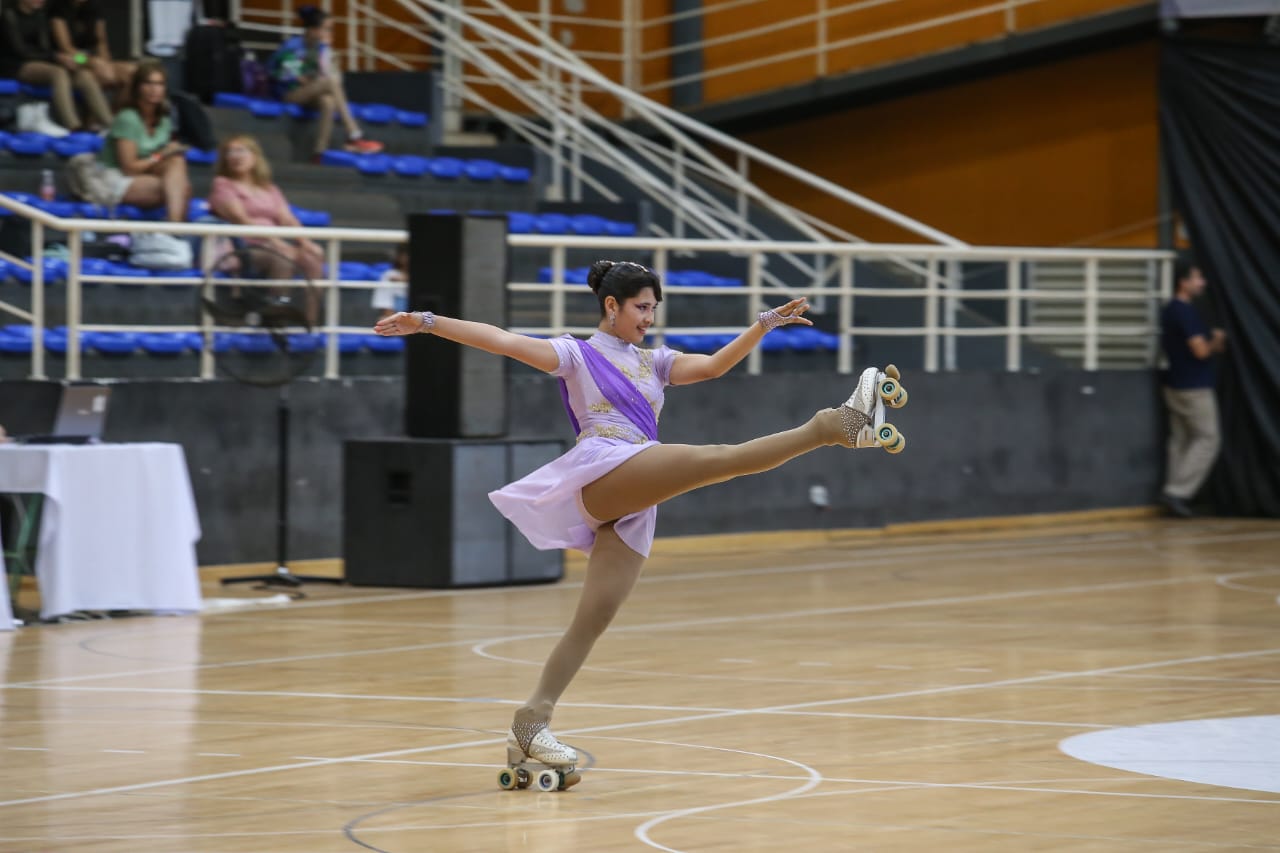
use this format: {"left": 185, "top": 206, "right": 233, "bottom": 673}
{"left": 268, "top": 6, "right": 383, "bottom": 161}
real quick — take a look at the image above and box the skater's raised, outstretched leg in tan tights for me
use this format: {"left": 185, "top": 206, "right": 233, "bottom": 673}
{"left": 582, "top": 407, "right": 867, "bottom": 520}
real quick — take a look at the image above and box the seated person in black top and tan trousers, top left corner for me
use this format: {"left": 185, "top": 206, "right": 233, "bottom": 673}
{"left": 0, "top": 0, "right": 111, "bottom": 136}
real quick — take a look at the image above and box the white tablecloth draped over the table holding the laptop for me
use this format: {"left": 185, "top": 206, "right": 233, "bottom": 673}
{"left": 0, "top": 444, "right": 201, "bottom": 619}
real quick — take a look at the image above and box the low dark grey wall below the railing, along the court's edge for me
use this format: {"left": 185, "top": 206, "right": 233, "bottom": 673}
{"left": 0, "top": 370, "right": 1161, "bottom": 565}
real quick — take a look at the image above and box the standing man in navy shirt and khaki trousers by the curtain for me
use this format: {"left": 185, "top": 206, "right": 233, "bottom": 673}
{"left": 1160, "top": 259, "right": 1226, "bottom": 519}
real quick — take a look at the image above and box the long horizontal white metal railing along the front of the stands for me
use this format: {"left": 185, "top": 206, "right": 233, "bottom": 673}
{"left": 0, "top": 196, "right": 1174, "bottom": 379}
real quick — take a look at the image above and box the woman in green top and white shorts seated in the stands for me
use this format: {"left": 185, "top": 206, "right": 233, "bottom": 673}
{"left": 99, "top": 60, "right": 191, "bottom": 222}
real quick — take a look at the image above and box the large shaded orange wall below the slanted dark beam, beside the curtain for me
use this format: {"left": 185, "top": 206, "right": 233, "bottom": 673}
{"left": 742, "top": 40, "right": 1158, "bottom": 246}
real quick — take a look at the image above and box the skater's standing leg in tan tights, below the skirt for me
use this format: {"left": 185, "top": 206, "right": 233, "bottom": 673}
{"left": 516, "top": 524, "right": 644, "bottom": 724}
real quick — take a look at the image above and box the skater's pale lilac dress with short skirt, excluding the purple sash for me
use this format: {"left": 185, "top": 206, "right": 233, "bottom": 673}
{"left": 489, "top": 332, "right": 678, "bottom": 557}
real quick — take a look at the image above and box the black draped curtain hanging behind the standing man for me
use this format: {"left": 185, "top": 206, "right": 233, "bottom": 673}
{"left": 1160, "top": 38, "right": 1280, "bottom": 517}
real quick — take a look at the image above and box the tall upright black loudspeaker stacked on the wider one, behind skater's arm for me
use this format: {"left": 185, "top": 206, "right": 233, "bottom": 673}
{"left": 404, "top": 214, "right": 507, "bottom": 438}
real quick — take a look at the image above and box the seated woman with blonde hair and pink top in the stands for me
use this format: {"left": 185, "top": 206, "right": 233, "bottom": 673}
{"left": 209, "top": 136, "right": 324, "bottom": 280}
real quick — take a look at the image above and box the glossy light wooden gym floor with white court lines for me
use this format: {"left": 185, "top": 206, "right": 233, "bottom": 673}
{"left": 0, "top": 514, "right": 1280, "bottom": 853}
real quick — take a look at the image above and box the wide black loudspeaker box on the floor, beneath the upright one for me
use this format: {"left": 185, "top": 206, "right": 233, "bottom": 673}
{"left": 343, "top": 438, "right": 564, "bottom": 589}
